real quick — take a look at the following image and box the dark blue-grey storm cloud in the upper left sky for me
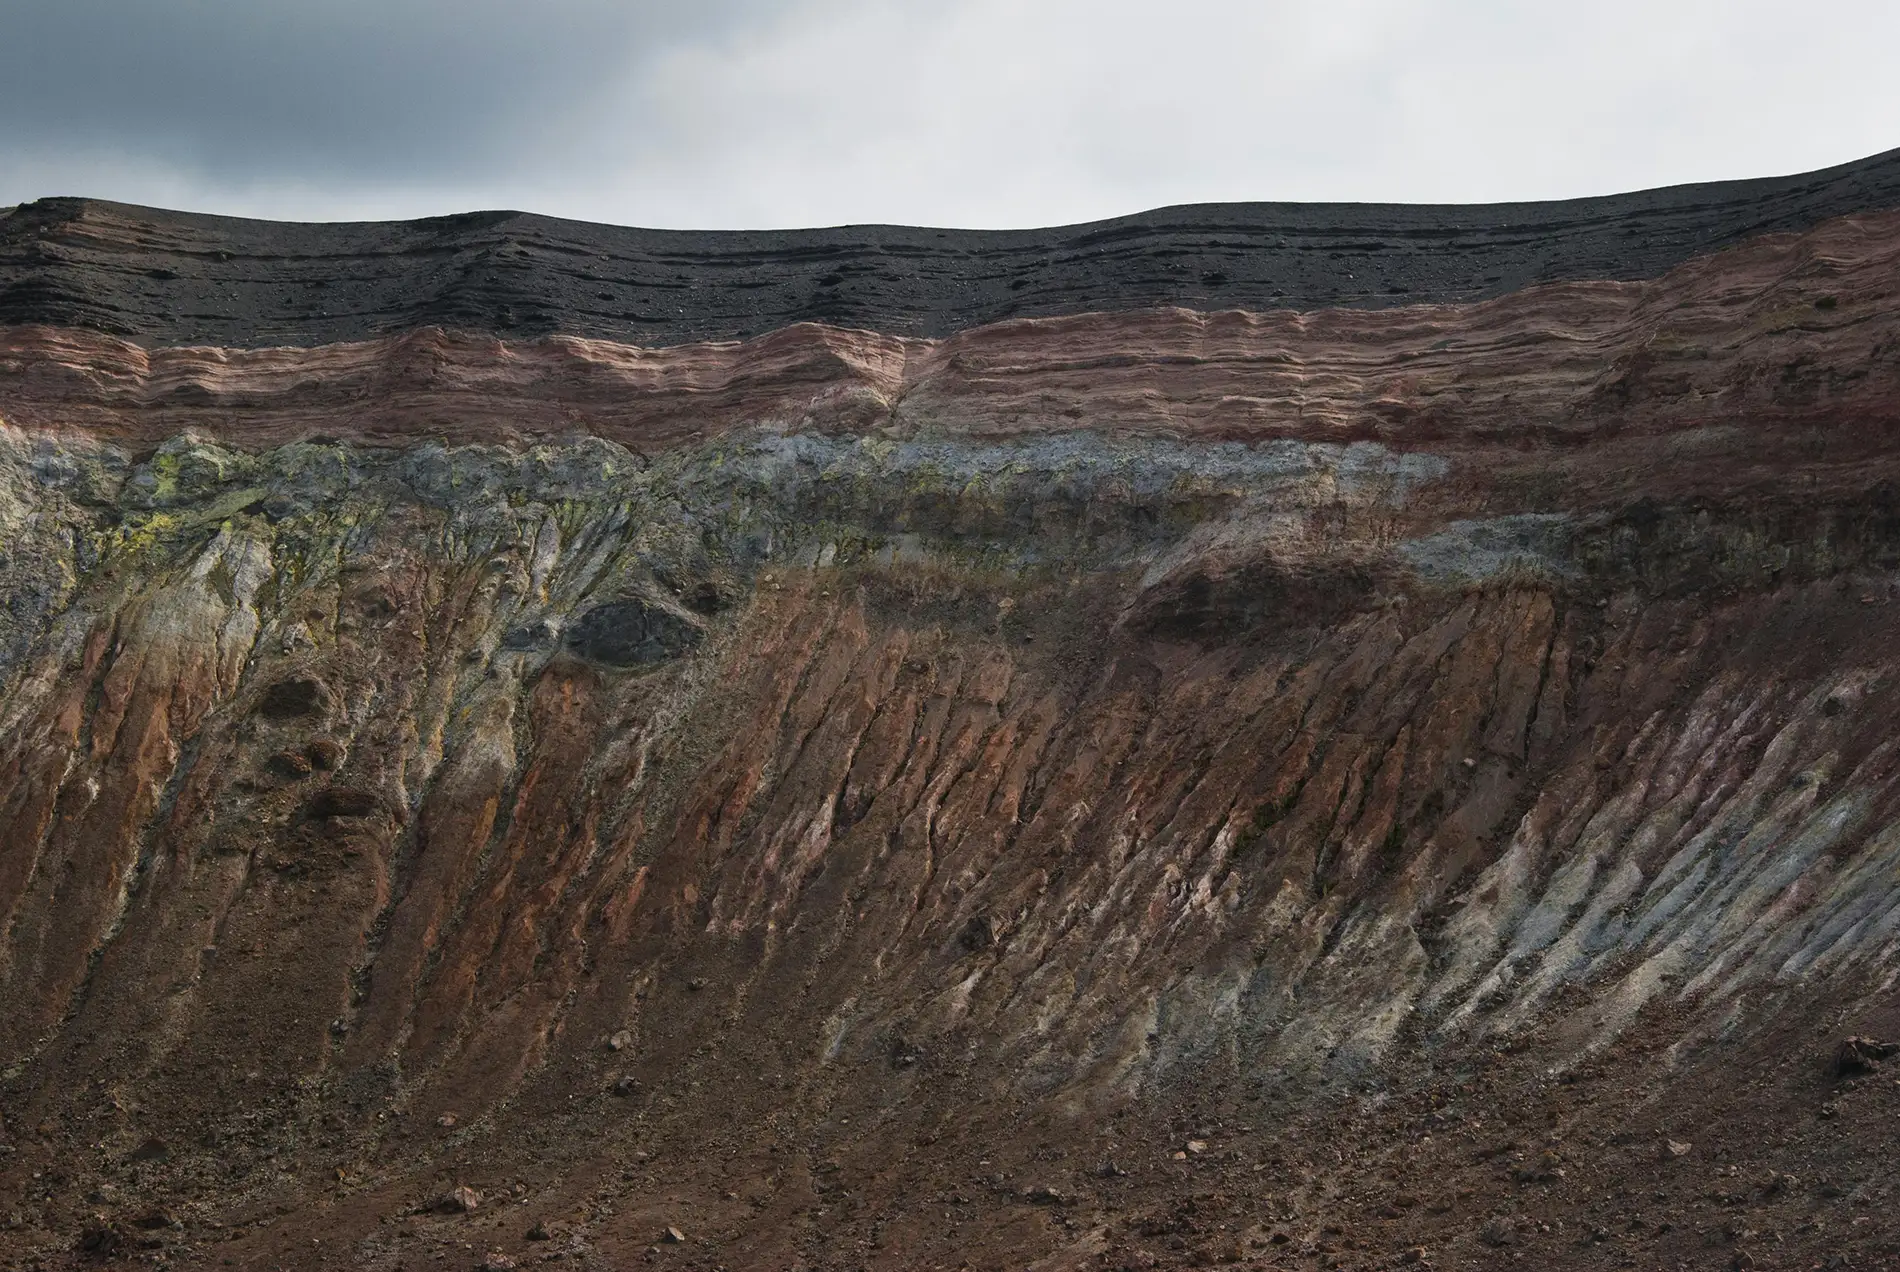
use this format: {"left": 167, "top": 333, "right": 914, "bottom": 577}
{"left": 0, "top": 0, "right": 762, "bottom": 183}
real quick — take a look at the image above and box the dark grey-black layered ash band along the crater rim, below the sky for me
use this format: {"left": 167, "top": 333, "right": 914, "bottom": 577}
{"left": 11, "top": 150, "right": 1900, "bottom": 348}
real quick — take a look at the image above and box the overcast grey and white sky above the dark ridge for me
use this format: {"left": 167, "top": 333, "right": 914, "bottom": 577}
{"left": 0, "top": 0, "right": 1900, "bottom": 228}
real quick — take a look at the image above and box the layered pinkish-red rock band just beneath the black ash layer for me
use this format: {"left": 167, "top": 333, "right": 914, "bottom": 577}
{"left": 0, "top": 200, "right": 1900, "bottom": 469}
